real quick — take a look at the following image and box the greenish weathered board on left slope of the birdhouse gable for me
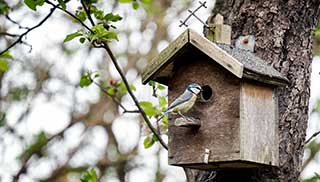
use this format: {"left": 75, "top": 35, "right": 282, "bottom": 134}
{"left": 142, "top": 29, "right": 189, "bottom": 84}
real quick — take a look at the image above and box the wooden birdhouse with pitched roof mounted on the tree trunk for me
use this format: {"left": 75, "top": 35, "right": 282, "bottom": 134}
{"left": 142, "top": 29, "right": 288, "bottom": 169}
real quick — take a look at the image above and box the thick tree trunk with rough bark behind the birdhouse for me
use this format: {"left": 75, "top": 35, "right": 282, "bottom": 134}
{"left": 191, "top": 0, "right": 320, "bottom": 181}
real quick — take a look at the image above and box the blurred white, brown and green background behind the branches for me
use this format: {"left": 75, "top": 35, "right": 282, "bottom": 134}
{"left": 0, "top": 0, "right": 320, "bottom": 182}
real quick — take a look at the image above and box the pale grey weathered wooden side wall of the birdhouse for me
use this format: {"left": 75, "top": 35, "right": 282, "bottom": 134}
{"left": 240, "top": 80, "right": 279, "bottom": 166}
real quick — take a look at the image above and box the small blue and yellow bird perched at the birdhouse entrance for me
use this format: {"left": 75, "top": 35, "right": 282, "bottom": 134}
{"left": 158, "top": 83, "right": 203, "bottom": 121}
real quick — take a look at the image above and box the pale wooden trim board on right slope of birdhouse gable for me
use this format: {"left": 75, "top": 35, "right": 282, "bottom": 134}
{"left": 189, "top": 30, "right": 243, "bottom": 78}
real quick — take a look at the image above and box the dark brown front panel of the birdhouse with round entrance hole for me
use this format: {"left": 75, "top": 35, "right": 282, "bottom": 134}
{"left": 168, "top": 51, "right": 240, "bottom": 168}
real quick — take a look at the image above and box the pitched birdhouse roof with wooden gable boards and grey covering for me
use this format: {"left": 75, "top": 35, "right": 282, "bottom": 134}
{"left": 142, "top": 29, "right": 288, "bottom": 85}
